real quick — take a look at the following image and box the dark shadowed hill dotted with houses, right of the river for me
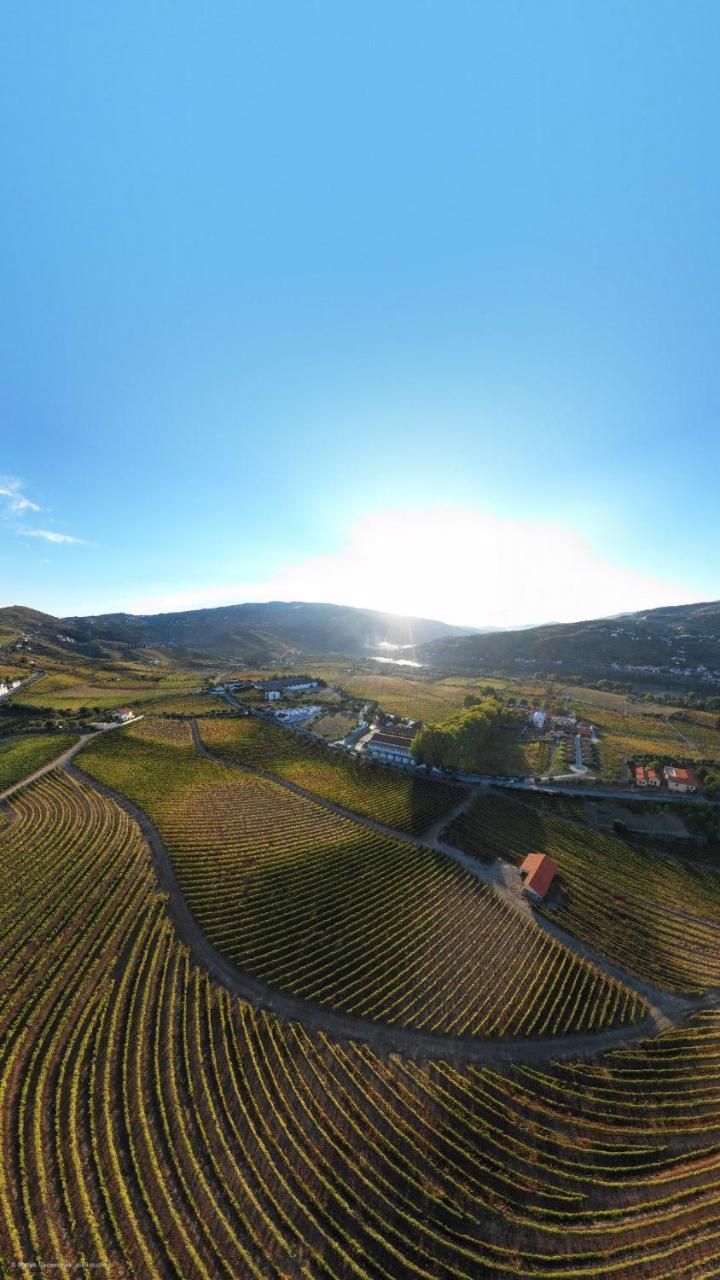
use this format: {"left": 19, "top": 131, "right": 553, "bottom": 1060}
{"left": 414, "top": 602, "right": 720, "bottom": 676}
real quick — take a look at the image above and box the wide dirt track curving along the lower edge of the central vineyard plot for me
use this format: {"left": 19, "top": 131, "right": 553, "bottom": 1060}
{"left": 67, "top": 764, "right": 702, "bottom": 1064}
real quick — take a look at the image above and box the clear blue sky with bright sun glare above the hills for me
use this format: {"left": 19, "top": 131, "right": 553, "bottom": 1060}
{"left": 0, "top": 0, "right": 720, "bottom": 625}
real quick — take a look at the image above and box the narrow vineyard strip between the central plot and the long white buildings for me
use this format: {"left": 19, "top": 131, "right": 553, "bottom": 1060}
{"left": 199, "top": 716, "right": 465, "bottom": 836}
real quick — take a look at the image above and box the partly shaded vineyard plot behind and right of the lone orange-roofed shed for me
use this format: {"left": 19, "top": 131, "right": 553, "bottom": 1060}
{"left": 442, "top": 794, "right": 720, "bottom": 993}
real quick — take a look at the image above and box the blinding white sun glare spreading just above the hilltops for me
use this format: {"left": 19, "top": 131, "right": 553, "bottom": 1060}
{"left": 129, "top": 507, "right": 693, "bottom": 627}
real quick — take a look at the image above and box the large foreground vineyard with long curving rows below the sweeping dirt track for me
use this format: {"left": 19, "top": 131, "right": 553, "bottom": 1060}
{"left": 0, "top": 774, "right": 720, "bottom": 1280}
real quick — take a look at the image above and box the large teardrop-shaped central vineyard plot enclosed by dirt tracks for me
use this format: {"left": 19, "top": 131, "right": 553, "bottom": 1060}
{"left": 79, "top": 721, "right": 643, "bottom": 1037}
